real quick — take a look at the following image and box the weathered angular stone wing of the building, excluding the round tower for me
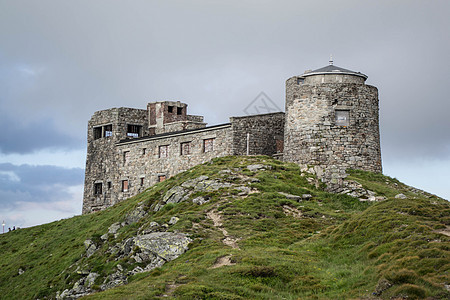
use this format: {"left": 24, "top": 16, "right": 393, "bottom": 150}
{"left": 83, "top": 106, "right": 284, "bottom": 213}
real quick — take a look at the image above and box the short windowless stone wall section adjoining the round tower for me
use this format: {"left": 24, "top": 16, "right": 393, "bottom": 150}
{"left": 230, "top": 112, "right": 284, "bottom": 155}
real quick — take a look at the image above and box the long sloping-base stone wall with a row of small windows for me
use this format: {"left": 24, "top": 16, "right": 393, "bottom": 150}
{"left": 95, "top": 124, "right": 232, "bottom": 208}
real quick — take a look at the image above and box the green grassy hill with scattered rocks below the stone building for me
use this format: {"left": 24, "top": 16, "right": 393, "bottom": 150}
{"left": 0, "top": 157, "right": 450, "bottom": 299}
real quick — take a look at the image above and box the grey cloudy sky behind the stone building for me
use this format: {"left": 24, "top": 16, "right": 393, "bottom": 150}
{"left": 0, "top": 0, "right": 450, "bottom": 228}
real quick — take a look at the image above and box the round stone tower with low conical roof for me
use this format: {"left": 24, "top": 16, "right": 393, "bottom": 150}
{"left": 284, "top": 61, "right": 381, "bottom": 190}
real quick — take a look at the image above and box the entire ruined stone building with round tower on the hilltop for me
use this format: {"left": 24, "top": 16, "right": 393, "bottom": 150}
{"left": 83, "top": 63, "right": 381, "bottom": 213}
